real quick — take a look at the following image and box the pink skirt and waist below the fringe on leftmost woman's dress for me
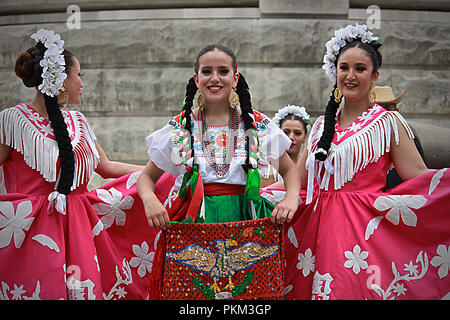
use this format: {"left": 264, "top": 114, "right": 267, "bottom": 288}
{"left": 0, "top": 105, "right": 173, "bottom": 299}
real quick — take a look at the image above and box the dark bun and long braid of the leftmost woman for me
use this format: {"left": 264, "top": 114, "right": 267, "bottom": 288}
{"left": 15, "top": 42, "right": 75, "bottom": 195}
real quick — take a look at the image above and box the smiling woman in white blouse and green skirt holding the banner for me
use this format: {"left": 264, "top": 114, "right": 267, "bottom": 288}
{"left": 138, "top": 45, "right": 299, "bottom": 229}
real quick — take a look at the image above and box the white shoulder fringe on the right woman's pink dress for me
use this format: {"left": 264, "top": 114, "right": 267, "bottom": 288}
{"left": 309, "top": 111, "right": 414, "bottom": 190}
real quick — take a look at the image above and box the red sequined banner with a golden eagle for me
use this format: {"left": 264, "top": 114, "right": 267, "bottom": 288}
{"left": 162, "top": 218, "right": 284, "bottom": 300}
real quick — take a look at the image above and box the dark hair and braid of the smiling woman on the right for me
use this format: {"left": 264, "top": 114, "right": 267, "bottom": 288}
{"left": 315, "top": 39, "right": 383, "bottom": 161}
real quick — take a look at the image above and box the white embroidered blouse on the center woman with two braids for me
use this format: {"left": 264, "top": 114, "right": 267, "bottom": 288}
{"left": 147, "top": 111, "right": 291, "bottom": 190}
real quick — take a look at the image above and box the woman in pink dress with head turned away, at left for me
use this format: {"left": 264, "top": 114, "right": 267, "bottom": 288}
{"left": 0, "top": 29, "right": 164, "bottom": 300}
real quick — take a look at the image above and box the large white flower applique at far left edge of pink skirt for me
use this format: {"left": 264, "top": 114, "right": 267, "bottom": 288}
{"left": 0, "top": 201, "right": 34, "bottom": 249}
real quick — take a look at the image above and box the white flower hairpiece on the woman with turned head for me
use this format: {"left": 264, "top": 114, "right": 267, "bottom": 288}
{"left": 31, "top": 29, "right": 67, "bottom": 97}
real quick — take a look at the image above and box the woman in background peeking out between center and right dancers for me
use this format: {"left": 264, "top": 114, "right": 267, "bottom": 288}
{"left": 261, "top": 104, "right": 311, "bottom": 188}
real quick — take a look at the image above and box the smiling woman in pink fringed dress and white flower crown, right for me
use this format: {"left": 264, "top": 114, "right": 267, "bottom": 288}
{"left": 285, "top": 24, "right": 450, "bottom": 299}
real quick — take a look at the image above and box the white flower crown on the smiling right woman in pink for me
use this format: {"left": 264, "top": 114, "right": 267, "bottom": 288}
{"left": 322, "top": 23, "right": 378, "bottom": 83}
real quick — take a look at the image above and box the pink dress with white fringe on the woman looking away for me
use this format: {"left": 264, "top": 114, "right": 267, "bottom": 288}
{"left": 0, "top": 104, "right": 169, "bottom": 300}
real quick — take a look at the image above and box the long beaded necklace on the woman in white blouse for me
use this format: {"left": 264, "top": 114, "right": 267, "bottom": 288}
{"left": 199, "top": 108, "right": 238, "bottom": 179}
